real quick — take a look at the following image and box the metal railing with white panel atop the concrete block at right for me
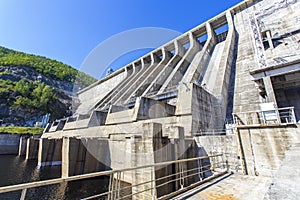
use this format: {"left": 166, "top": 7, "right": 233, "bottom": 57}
{"left": 232, "top": 107, "right": 296, "bottom": 125}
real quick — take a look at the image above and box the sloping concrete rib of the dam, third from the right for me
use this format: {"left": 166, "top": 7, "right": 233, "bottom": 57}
{"left": 158, "top": 32, "right": 200, "bottom": 94}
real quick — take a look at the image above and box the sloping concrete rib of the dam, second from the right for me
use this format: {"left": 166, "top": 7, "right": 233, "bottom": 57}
{"left": 182, "top": 22, "right": 217, "bottom": 83}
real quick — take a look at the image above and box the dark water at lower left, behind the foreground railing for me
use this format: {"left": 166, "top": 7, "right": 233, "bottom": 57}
{"left": 0, "top": 155, "right": 108, "bottom": 200}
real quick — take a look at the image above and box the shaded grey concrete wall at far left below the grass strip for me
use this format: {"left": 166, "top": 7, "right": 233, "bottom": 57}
{"left": 0, "top": 134, "right": 20, "bottom": 155}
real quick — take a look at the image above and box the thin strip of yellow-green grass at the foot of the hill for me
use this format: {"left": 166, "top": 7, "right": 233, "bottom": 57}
{"left": 0, "top": 126, "right": 44, "bottom": 135}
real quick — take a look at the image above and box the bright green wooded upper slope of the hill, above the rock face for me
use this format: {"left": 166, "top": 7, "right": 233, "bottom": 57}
{"left": 0, "top": 46, "right": 96, "bottom": 87}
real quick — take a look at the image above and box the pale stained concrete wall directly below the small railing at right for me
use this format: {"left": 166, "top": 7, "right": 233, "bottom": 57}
{"left": 238, "top": 126, "right": 300, "bottom": 176}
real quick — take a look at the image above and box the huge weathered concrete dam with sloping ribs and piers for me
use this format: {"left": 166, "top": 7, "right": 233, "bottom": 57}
{"left": 0, "top": 0, "right": 300, "bottom": 199}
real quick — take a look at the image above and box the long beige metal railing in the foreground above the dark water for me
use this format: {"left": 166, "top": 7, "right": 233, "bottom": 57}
{"left": 0, "top": 154, "right": 229, "bottom": 200}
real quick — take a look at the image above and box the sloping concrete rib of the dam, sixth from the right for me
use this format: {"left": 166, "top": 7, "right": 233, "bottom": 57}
{"left": 114, "top": 53, "right": 160, "bottom": 104}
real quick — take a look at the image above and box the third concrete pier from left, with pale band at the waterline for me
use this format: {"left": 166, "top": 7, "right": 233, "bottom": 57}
{"left": 38, "top": 138, "right": 62, "bottom": 167}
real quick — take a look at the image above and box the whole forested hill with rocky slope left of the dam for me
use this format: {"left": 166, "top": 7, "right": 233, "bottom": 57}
{"left": 0, "top": 46, "right": 96, "bottom": 126}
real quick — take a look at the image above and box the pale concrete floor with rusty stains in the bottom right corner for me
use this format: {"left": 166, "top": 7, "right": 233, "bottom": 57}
{"left": 180, "top": 143, "right": 300, "bottom": 200}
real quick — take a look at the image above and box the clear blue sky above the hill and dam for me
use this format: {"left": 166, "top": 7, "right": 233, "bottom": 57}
{"left": 0, "top": 0, "right": 242, "bottom": 78}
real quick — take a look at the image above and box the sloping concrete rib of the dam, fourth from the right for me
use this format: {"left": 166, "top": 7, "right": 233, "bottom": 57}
{"left": 142, "top": 40, "right": 185, "bottom": 96}
